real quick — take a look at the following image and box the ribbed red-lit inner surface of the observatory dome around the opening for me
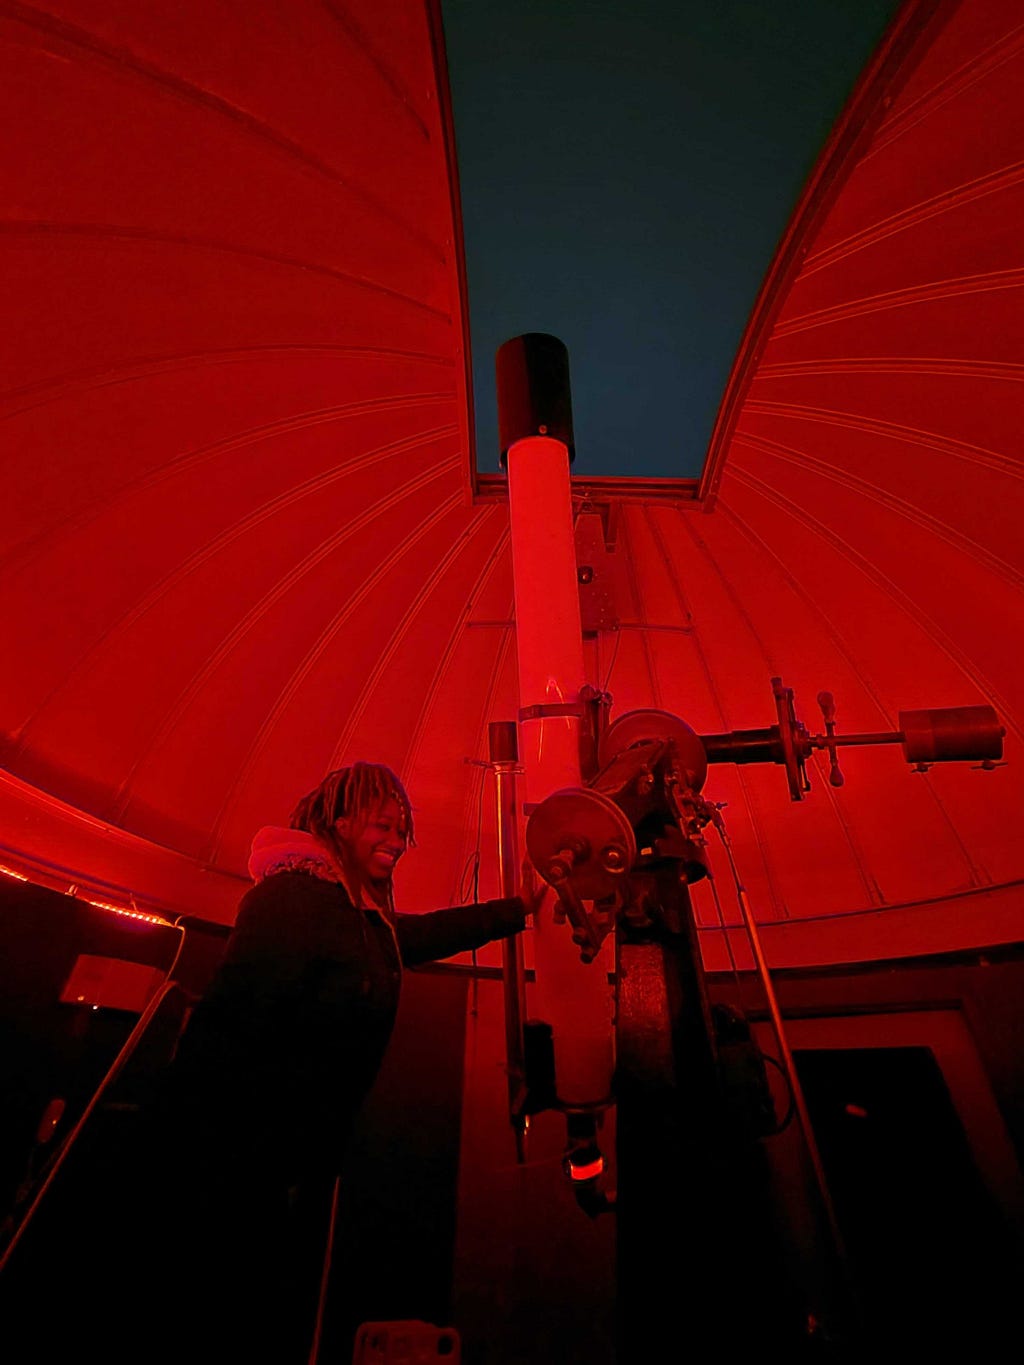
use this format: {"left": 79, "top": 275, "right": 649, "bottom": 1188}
{"left": 0, "top": 0, "right": 1024, "bottom": 966}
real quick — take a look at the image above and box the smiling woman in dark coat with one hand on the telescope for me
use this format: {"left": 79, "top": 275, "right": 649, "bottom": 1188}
{"left": 0, "top": 763, "right": 541, "bottom": 1365}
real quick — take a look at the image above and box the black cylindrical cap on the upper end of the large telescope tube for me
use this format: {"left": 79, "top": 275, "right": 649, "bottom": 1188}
{"left": 494, "top": 332, "right": 576, "bottom": 470}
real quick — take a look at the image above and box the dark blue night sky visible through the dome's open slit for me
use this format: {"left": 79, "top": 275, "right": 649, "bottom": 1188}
{"left": 442, "top": 0, "right": 898, "bottom": 478}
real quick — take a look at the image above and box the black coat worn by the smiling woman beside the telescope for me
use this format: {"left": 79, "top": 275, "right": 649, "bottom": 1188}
{"left": 164, "top": 871, "right": 524, "bottom": 1185}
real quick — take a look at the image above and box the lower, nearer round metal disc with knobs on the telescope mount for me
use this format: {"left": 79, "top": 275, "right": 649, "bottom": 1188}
{"left": 526, "top": 786, "right": 636, "bottom": 962}
